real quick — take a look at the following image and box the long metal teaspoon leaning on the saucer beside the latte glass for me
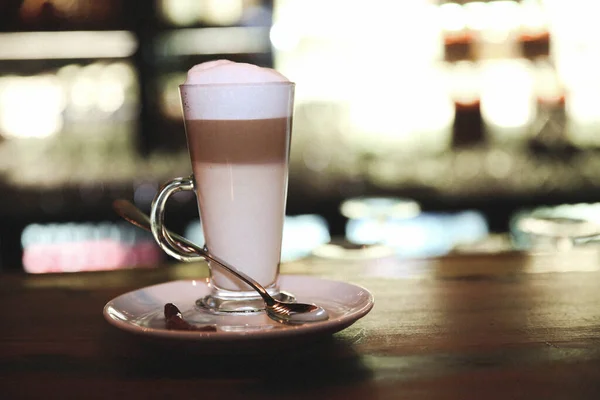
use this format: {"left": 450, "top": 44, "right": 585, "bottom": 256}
{"left": 113, "top": 199, "right": 329, "bottom": 324}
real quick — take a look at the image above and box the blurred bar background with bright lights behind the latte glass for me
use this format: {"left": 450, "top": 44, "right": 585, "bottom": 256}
{"left": 0, "top": 0, "right": 600, "bottom": 273}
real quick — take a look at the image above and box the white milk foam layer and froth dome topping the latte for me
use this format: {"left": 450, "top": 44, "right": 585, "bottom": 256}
{"left": 181, "top": 60, "right": 293, "bottom": 120}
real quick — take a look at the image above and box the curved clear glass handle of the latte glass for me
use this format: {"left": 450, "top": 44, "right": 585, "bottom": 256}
{"left": 150, "top": 177, "right": 204, "bottom": 262}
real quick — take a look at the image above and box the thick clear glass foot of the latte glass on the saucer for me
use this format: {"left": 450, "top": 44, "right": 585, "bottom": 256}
{"left": 196, "top": 290, "right": 296, "bottom": 314}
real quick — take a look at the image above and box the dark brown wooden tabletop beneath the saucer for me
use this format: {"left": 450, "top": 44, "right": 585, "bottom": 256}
{"left": 0, "top": 254, "right": 600, "bottom": 400}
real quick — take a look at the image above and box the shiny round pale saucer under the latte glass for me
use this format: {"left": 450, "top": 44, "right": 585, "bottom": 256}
{"left": 104, "top": 275, "right": 373, "bottom": 343}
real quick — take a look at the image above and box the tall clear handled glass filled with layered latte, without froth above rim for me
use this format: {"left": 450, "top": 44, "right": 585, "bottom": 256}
{"left": 151, "top": 82, "right": 294, "bottom": 312}
